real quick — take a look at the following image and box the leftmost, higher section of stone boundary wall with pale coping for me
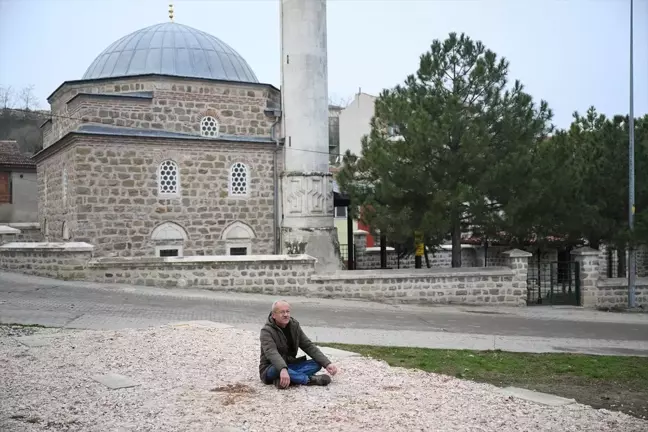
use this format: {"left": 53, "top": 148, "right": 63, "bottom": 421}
{"left": 0, "top": 242, "right": 94, "bottom": 280}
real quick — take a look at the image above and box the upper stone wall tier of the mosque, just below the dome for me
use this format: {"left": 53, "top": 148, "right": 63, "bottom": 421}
{"left": 43, "top": 76, "right": 280, "bottom": 147}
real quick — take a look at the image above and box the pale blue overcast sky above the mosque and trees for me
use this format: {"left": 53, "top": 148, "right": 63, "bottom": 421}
{"left": 0, "top": 0, "right": 648, "bottom": 127}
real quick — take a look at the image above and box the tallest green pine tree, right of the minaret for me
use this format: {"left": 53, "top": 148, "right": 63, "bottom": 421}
{"left": 338, "top": 33, "right": 551, "bottom": 267}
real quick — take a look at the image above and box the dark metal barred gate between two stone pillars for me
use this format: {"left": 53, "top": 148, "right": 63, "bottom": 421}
{"left": 527, "top": 261, "right": 580, "bottom": 306}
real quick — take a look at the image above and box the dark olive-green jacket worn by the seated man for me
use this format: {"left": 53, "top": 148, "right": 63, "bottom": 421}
{"left": 259, "top": 313, "right": 331, "bottom": 382}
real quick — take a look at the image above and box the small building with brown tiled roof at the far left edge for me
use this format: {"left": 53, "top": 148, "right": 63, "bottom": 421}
{"left": 0, "top": 141, "right": 38, "bottom": 223}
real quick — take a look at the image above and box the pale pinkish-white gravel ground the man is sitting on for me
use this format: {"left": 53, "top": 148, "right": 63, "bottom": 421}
{"left": 0, "top": 326, "right": 648, "bottom": 432}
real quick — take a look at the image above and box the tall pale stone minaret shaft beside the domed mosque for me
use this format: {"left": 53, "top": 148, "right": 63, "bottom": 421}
{"left": 281, "top": 0, "right": 341, "bottom": 271}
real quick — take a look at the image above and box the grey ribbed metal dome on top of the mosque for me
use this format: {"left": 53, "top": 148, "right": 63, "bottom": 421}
{"left": 83, "top": 22, "right": 259, "bottom": 83}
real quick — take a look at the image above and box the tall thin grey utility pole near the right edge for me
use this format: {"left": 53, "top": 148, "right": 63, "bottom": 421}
{"left": 628, "top": 0, "right": 637, "bottom": 308}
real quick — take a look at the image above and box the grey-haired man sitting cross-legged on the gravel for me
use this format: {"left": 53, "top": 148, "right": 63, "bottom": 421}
{"left": 259, "top": 300, "right": 337, "bottom": 389}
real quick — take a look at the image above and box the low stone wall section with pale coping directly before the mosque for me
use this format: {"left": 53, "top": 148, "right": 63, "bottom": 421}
{"left": 88, "top": 255, "right": 315, "bottom": 295}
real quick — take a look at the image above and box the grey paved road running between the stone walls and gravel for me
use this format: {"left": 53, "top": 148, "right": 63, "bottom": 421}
{"left": 0, "top": 273, "right": 648, "bottom": 342}
